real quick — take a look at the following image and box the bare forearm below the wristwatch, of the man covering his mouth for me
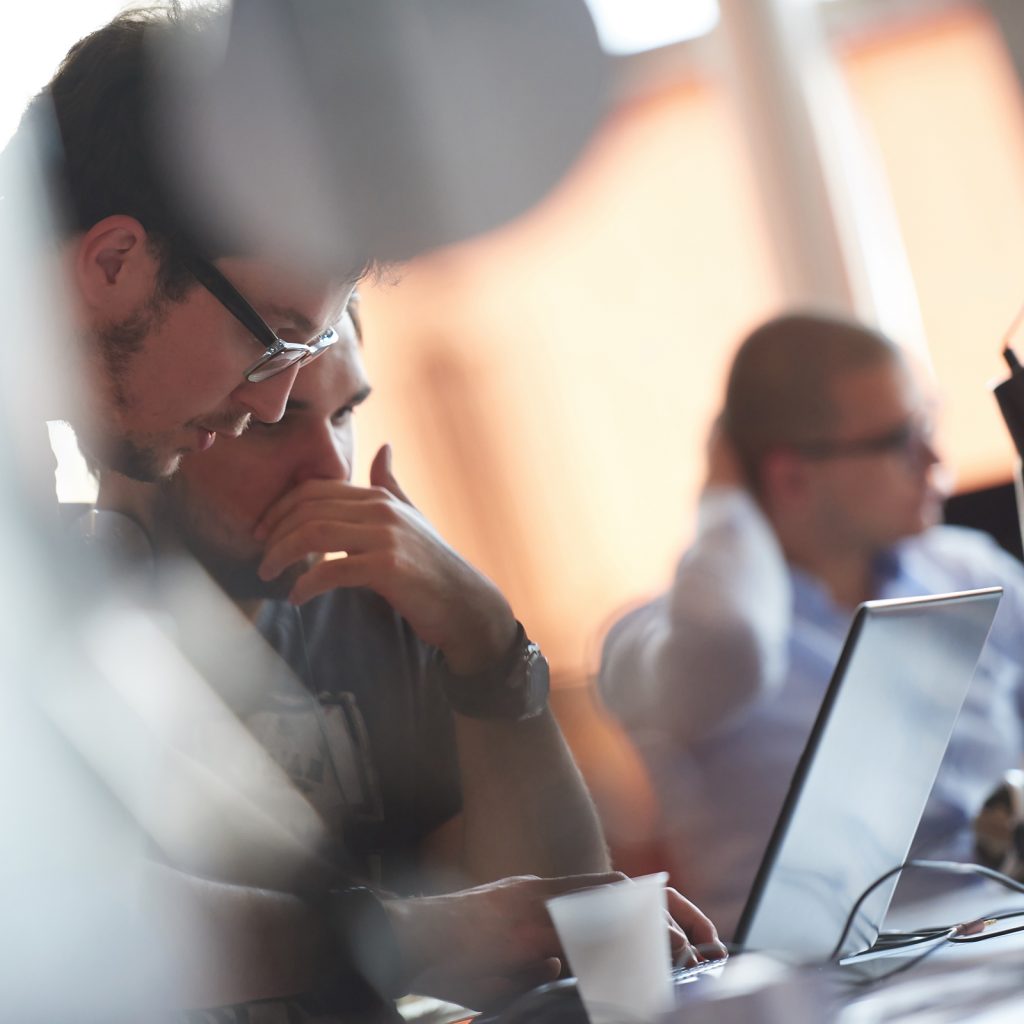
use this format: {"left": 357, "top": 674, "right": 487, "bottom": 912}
{"left": 456, "top": 710, "right": 609, "bottom": 882}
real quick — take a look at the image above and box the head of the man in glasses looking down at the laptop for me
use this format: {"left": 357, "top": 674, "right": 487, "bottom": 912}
{"left": 23, "top": 9, "right": 362, "bottom": 480}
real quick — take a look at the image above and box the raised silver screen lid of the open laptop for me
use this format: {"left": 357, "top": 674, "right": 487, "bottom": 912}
{"left": 735, "top": 587, "right": 1002, "bottom": 963}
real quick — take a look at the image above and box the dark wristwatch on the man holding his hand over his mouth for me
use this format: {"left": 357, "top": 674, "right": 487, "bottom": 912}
{"left": 433, "top": 621, "right": 551, "bottom": 722}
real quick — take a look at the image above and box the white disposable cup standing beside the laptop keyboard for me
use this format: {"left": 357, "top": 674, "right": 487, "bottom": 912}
{"left": 547, "top": 871, "right": 673, "bottom": 1024}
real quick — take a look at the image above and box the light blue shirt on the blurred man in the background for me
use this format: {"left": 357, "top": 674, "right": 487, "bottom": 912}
{"left": 599, "top": 490, "right": 1024, "bottom": 936}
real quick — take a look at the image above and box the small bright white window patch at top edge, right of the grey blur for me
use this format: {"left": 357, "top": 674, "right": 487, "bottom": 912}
{"left": 587, "top": 0, "right": 718, "bottom": 55}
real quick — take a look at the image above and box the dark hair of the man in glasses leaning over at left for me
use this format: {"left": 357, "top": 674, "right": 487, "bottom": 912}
{"left": 27, "top": 3, "right": 224, "bottom": 297}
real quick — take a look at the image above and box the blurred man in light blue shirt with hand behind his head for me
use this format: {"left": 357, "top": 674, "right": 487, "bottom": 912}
{"left": 600, "top": 314, "right": 1024, "bottom": 935}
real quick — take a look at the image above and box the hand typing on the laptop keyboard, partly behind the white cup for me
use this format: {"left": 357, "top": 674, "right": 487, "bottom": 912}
{"left": 385, "top": 871, "right": 726, "bottom": 1009}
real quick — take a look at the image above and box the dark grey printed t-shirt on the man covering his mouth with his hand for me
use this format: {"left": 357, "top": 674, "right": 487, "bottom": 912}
{"left": 249, "top": 589, "right": 462, "bottom": 893}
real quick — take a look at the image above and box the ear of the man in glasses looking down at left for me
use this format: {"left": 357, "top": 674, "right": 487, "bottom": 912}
{"left": 74, "top": 220, "right": 157, "bottom": 319}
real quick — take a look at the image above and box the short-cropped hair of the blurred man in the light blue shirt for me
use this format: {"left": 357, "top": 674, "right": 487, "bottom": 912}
{"left": 722, "top": 312, "right": 902, "bottom": 489}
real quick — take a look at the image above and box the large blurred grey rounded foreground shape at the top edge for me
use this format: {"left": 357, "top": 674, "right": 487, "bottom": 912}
{"left": 157, "top": 0, "right": 608, "bottom": 267}
